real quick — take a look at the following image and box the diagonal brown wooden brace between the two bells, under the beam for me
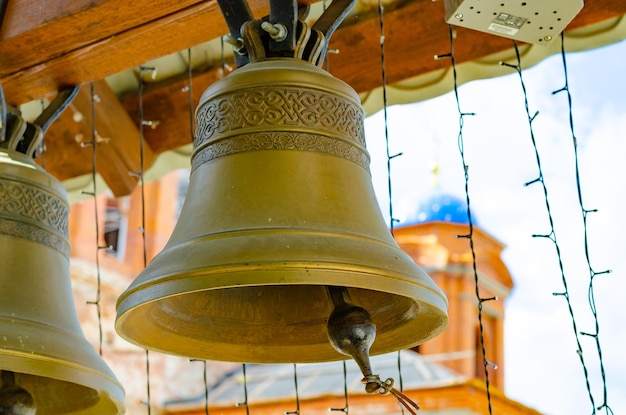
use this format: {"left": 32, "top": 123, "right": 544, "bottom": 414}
{"left": 41, "top": 81, "right": 154, "bottom": 197}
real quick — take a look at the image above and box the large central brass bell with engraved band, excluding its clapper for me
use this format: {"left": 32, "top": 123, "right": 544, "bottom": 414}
{"left": 116, "top": 52, "right": 447, "bottom": 363}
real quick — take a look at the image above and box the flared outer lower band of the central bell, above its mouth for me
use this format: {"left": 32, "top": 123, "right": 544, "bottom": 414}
{"left": 116, "top": 227, "right": 448, "bottom": 314}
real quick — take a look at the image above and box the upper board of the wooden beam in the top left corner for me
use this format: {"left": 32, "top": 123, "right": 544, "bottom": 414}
{"left": 0, "top": 0, "right": 202, "bottom": 75}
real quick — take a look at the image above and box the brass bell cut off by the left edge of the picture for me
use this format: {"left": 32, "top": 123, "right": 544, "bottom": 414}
{"left": 0, "top": 143, "right": 124, "bottom": 415}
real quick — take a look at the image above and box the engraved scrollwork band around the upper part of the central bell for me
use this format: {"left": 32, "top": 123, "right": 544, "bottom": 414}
{"left": 192, "top": 86, "right": 369, "bottom": 171}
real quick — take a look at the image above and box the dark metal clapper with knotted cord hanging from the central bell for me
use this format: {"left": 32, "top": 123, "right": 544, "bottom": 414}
{"left": 326, "top": 286, "right": 419, "bottom": 415}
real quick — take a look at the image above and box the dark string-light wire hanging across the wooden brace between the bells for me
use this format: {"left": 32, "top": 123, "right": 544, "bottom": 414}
{"left": 81, "top": 82, "right": 108, "bottom": 356}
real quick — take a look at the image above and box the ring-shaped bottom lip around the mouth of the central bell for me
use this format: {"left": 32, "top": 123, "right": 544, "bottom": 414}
{"left": 115, "top": 265, "right": 448, "bottom": 363}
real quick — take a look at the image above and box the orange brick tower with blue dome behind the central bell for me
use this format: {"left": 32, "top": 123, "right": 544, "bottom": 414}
{"left": 394, "top": 194, "right": 513, "bottom": 389}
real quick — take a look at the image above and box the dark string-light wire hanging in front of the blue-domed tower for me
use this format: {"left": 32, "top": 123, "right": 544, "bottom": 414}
{"left": 435, "top": 25, "right": 498, "bottom": 414}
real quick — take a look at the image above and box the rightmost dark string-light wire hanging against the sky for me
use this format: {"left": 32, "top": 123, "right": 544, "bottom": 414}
{"left": 552, "top": 32, "right": 613, "bottom": 414}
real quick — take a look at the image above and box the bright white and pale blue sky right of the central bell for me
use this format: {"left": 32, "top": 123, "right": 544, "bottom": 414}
{"left": 365, "top": 40, "right": 626, "bottom": 415}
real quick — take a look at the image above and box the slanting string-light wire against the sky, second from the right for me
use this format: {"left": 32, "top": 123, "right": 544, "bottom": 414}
{"left": 500, "top": 41, "right": 596, "bottom": 414}
